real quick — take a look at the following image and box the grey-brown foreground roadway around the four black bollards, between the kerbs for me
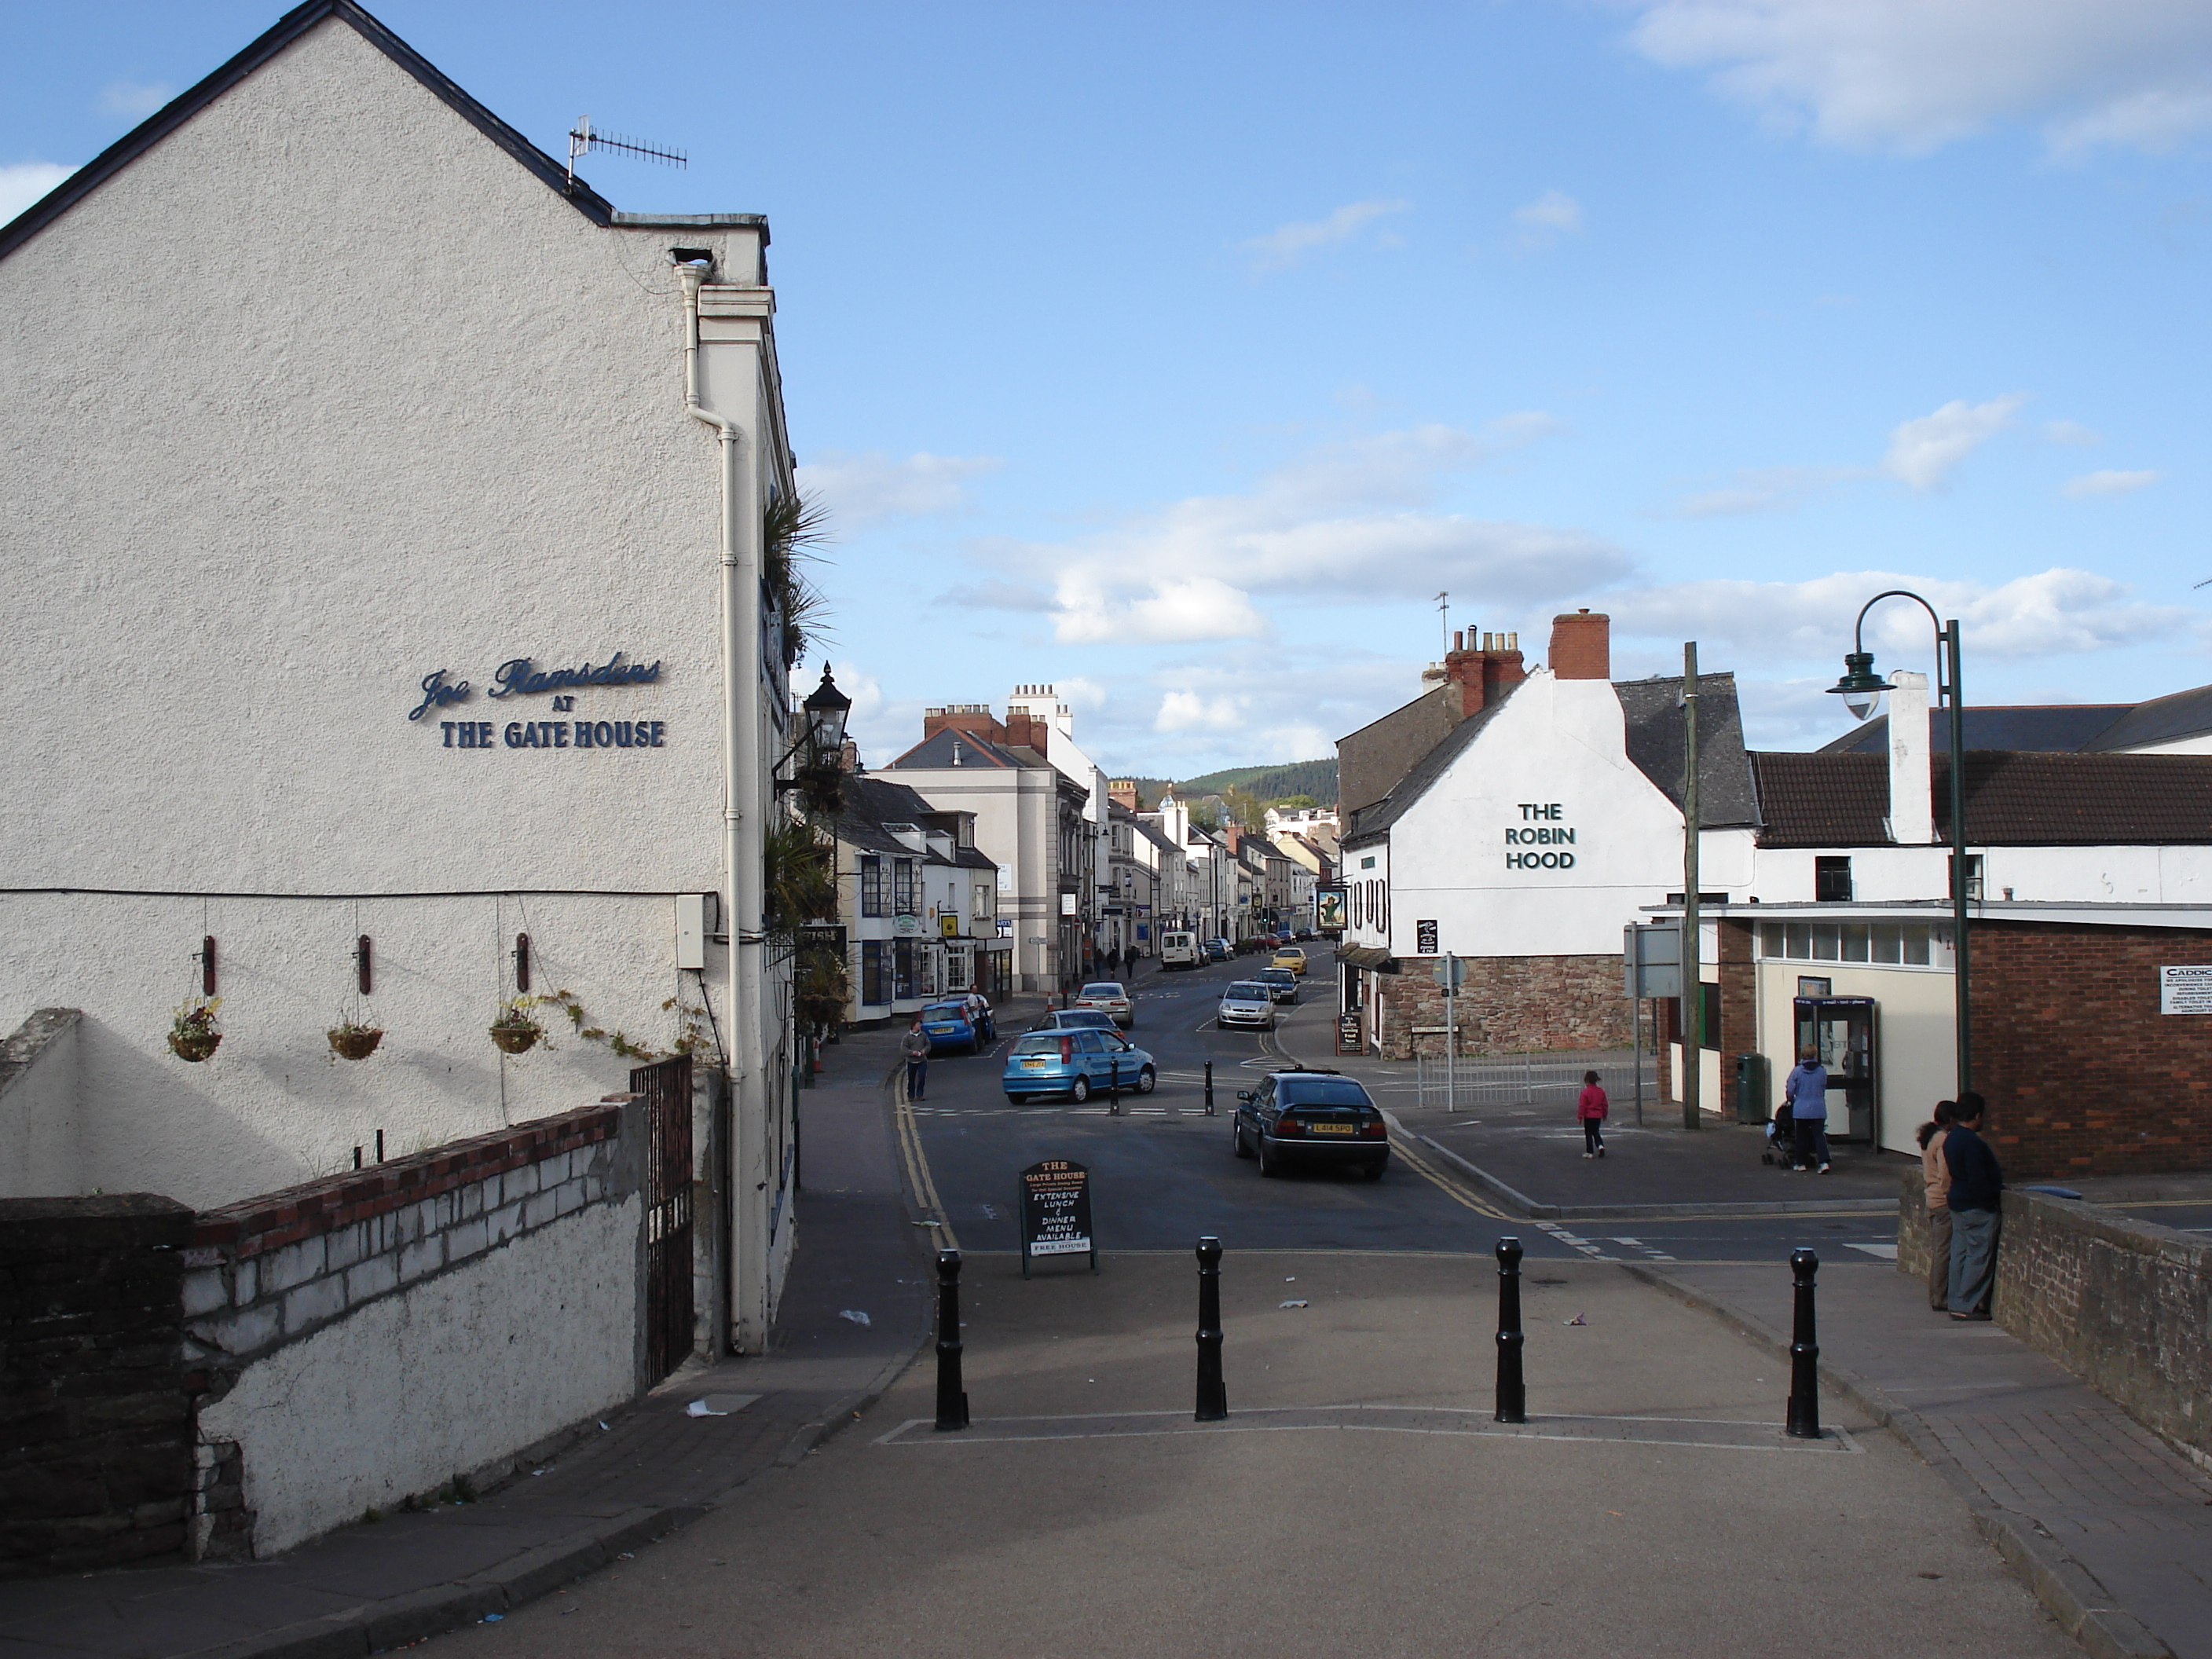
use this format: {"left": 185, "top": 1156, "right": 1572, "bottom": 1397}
{"left": 411, "top": 1252, "right": 2073, "bottom": 1659}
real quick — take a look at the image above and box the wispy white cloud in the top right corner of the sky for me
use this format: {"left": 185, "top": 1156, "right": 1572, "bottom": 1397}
{"left": 1628, "top": 0, "right": 2212, "bottom": 155}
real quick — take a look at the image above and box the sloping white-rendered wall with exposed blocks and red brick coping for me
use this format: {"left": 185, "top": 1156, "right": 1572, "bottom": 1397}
{"left": 181, "top": 1095, "right": 646, "bottom": 1559}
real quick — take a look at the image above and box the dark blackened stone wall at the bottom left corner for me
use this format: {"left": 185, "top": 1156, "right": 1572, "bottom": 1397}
{"left": 0, "top": 1192, "right": 192, "bottom": 1577}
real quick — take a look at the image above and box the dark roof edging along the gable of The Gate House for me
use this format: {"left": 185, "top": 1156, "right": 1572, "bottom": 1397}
{"left": 0, "top": 0, "right": 767, "bottom": 258}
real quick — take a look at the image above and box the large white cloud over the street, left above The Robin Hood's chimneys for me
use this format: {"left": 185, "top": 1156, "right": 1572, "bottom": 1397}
{"left": 982, "top": 414, "right": 1630, "bottom": 643}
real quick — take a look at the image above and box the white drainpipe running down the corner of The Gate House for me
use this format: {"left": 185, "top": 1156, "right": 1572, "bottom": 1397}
{"left": 675, "top": 266, "right": 770, "bottom": 1353}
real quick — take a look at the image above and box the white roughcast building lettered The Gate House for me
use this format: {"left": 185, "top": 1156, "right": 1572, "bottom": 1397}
{"left": 0, "top": 0, "right": 797, "bottom": 1347}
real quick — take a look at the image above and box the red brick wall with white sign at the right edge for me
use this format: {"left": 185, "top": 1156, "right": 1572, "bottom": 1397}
{"left": 1968, "top": 922, "right": 2212, "bottom": 1181}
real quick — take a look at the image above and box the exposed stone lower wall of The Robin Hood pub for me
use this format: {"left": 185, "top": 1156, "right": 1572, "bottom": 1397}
{"left": 1369, "top": 956, "right": 1630, "bottom": 1060}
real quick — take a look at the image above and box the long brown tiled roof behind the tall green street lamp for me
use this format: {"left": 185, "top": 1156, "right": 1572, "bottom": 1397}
{"left": 1749, "top": 750, "right": 2212, "bottom": 848}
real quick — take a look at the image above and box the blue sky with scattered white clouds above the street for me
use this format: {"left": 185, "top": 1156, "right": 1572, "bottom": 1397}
{"left": 0, "top": 0, "right": 2212, "bottom": 776}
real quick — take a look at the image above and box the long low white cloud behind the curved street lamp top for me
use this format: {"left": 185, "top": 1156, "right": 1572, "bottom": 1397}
{"left": 1606, "top": 566, "right": 2196, "bottom": 672}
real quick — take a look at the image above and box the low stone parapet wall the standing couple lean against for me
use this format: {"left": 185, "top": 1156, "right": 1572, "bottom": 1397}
{"left": 1898, "top": 1168, "right": 2212, "bottom": 1453}
